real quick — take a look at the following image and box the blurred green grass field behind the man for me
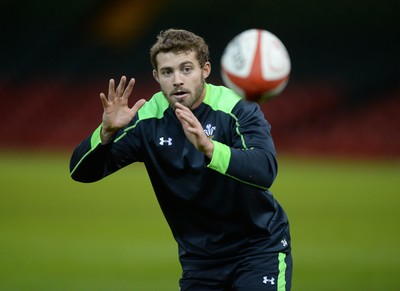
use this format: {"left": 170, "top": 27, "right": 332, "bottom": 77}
{"left": 0, "top": 152, "right": 400, "bottom": 291}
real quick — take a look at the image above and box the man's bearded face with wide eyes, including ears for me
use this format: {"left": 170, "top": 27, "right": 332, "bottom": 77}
{"left": 153, "top": 51, "right": 211, "bottom": 109}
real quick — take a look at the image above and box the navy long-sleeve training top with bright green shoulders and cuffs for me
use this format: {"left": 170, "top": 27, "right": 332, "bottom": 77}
{"left": 70, "top": 84, "right": 290, "bottom": 269}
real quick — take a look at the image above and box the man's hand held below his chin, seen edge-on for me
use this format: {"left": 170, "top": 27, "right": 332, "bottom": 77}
{"left": 174, "top": 102, "right": 214, "bottom": 160}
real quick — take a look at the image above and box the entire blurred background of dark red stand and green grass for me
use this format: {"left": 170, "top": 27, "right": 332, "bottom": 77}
{"left": 0, "top": 0, "right": 400, "bottom": 291}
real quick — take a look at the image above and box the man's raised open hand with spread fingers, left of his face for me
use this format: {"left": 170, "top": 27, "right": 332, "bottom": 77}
{"left": 100, "top": 76, "right": 146, "bottom": 144}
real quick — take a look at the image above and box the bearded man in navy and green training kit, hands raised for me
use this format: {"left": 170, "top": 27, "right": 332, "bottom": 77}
{"left": 70, "top": 29, "right": 292, "bottom": 291}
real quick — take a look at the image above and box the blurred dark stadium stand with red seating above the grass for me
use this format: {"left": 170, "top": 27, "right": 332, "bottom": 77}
{"left": 0, "top": 0, "right": 400, "bottom": 158}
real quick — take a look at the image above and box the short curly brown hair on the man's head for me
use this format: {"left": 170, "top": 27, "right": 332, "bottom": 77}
{"left": 150, "top": 29, "right": 209, "bottom": 70}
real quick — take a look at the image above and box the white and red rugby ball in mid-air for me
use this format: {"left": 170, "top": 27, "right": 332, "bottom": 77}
{"left": 221, "top": 29, "right": 291, "bottom": 102}
